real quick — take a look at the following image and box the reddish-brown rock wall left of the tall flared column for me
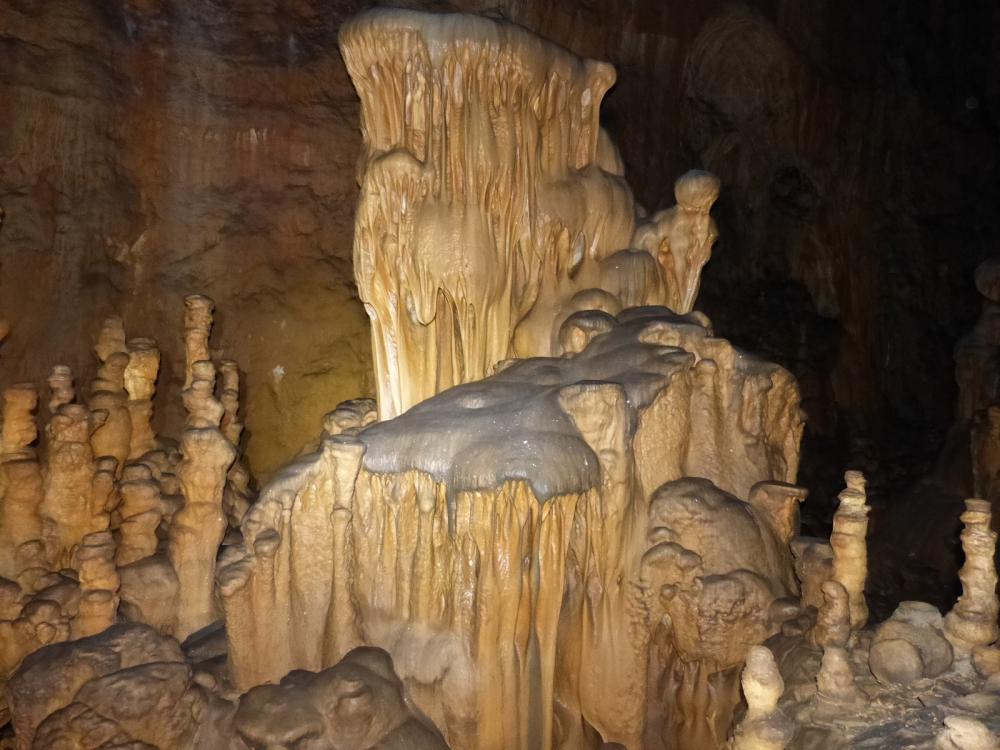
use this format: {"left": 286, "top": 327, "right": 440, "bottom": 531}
{"left": 0, "top": 0, "right": 371, "bottom": 473}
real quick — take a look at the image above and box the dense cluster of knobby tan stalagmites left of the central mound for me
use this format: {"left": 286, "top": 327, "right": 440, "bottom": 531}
{"left": 0, "top": 296, "right": 249, "bottom": 680}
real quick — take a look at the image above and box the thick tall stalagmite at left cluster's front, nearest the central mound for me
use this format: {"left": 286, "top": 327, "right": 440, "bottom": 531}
{"left": 168, "top": 360, "right": 236, "bottom": 640}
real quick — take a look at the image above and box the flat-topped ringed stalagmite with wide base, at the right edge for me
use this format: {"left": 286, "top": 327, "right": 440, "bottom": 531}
{"left": 944, "top": 498, "right": 1000, "bottom": 658}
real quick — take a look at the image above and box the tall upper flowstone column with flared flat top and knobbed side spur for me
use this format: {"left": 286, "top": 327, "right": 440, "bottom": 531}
{"left": 340, "top": 10, "right": 719, "bottom": 419}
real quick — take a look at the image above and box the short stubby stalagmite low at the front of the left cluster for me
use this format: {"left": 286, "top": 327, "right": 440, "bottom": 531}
{"left": 70, "top": 531, "right": 121, "bottom": 638}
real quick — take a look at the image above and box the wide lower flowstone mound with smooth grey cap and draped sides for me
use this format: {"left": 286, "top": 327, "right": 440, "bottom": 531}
{"left": 219, "top": 308, "right": 804, "bottom": 748}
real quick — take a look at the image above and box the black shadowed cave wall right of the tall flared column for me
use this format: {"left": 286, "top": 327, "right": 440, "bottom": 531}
{"left": 606, "top": 0, "right": 1000, "bottom": 614}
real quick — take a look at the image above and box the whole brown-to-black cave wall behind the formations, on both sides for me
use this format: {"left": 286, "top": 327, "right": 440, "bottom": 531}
{"left": 0, "top": 0, "right": 1000, "bottom": 494}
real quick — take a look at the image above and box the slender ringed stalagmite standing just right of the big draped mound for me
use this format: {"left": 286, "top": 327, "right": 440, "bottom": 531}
{"left": 830, "top": 471, "right": 871, "bottom": 631}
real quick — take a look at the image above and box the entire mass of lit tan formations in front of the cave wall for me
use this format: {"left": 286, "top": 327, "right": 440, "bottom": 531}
{"left": 0, "top": 10, "right": 1000, "bottom": 750}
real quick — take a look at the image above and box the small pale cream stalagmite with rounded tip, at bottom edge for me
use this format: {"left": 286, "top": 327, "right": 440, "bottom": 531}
{"left": 733, "top": 646, "right": 795, "bottom": 750}
